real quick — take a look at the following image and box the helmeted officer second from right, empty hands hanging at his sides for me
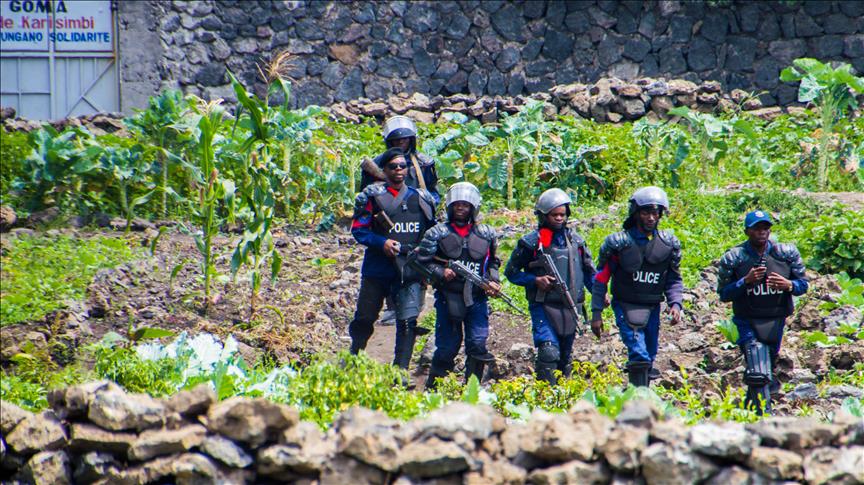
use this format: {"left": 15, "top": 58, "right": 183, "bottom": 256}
{"left": 591, "top": 187, "right": 683, "bottom": 386}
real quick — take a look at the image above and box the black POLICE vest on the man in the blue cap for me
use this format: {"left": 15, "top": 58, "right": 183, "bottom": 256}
{"left": 732, "top": 251, "right": 792, "bottom": 318}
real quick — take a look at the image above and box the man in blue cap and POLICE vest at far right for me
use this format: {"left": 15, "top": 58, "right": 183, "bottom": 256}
{"left": 717, "top": 210, "right": 809, "bottom": 414}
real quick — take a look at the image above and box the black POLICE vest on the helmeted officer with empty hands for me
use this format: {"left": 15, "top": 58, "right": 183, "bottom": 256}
{"left": 612, "top": 236, "right": 672, "bottom": 305}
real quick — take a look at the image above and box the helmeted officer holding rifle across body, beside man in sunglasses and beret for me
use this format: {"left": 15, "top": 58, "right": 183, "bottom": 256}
{"left": 417, "top": 182, "right": 501, "bottom": 389}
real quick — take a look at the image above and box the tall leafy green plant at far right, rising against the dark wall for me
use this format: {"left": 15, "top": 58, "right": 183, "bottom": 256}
{"left": 780, "top": 58, "right": 864, "bottom": 190}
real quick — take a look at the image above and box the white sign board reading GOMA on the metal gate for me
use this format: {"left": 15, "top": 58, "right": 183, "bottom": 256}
{"left": 0, "top": 0, "right": 114, "bottom": 52}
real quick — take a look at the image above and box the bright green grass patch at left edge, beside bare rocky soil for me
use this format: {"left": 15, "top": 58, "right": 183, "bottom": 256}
{"left": 0, "top": 236, "right": 135, "bottom": 326}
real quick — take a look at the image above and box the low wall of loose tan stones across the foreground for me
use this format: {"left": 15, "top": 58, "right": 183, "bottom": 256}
{"left": 0, "top": 382, "right": 864, "bottom": 485}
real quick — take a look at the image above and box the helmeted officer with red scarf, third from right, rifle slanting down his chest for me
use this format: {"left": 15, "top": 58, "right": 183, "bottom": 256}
{"left": 504, "top": 189, "right": 595, "bottom": 385}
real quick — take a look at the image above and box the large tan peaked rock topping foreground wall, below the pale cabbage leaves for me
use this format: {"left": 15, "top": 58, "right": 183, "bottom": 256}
{"left": 206, "top": 397, "right": 299, "bottom": 448}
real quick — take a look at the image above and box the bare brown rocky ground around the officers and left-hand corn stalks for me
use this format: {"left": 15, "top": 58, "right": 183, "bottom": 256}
{"left": 2, "top": 204, "right": 864, "bottom": 414}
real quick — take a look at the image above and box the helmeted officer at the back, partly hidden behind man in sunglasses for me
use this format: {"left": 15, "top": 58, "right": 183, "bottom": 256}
{"left": 360, "top": 116, "right": 441, "bottom": 205}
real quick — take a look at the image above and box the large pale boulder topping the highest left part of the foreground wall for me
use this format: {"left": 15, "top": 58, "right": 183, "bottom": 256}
{"left": 87, "top": 386, "right": 166, "bottom": 431}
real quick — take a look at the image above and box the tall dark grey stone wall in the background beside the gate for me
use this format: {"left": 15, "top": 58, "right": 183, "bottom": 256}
{"left": 119, "top": 0, "right": 864, "bottom": 112}
